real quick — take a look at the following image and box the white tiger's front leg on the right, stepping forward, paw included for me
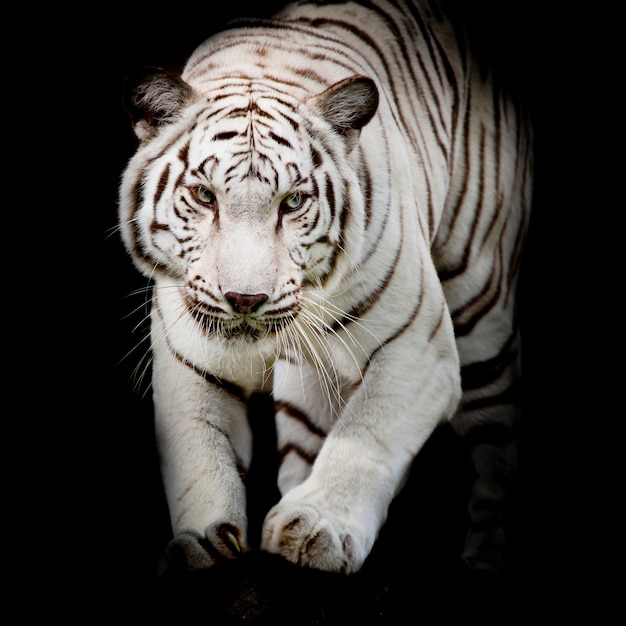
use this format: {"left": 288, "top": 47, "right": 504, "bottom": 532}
{"left": 261, "top": 325, "right": 460, "bottom": 574}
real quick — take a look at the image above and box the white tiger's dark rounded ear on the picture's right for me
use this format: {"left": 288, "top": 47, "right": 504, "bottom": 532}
{"left": 310, "top": 76, "right": 378, "bottom": 151}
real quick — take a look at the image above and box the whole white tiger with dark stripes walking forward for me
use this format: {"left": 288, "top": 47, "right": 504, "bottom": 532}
{"left": 119, "top": 0, "right": 532, "bottom": 573}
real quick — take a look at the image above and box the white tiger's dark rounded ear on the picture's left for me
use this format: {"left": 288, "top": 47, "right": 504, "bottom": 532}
{"left": 122, "top": 67, "right": 194, "bottom": 142}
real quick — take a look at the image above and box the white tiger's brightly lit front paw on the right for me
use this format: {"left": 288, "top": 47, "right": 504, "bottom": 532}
{"left": 261, "top": 502, "right": 365, "bottom": 574}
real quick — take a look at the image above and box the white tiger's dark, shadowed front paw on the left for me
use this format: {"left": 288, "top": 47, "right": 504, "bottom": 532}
{"left": 161, "top": 523, "right": 245, "bottom": 576}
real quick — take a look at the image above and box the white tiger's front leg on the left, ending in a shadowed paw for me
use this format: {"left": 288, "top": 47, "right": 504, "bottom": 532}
{"left": 153, "top": 330, "right": 251, "bottom": 574}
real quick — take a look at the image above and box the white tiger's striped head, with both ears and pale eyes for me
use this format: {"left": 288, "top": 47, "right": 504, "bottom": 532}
{"left": 119, "top": 68, "right": 378, "bottom": 346}
